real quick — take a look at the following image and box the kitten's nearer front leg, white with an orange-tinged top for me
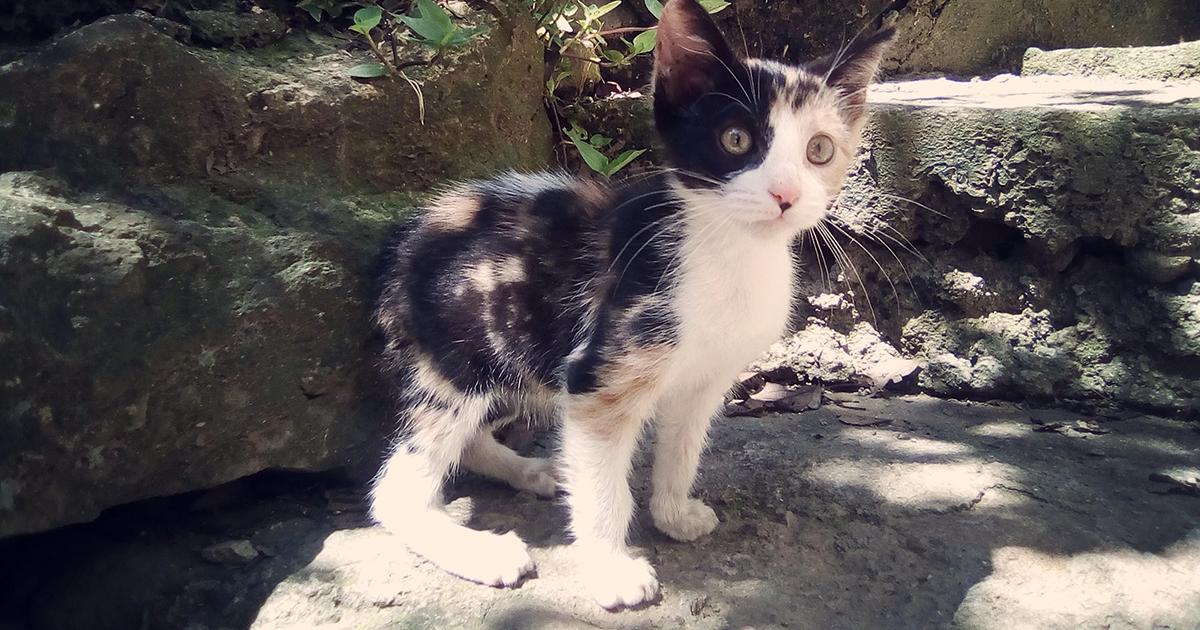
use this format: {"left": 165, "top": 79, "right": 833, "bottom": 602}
{"left": 562, "top": 388, "right": 659, "bottom": 610}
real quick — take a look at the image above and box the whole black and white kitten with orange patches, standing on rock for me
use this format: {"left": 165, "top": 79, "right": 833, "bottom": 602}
{"left": 371, "top": 0, "right": 893, "bottom": 608}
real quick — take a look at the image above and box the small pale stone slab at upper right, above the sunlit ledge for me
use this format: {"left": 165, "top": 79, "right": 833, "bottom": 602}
{"left": 1021, "top": 42, "right": 1200, "bottom": 80}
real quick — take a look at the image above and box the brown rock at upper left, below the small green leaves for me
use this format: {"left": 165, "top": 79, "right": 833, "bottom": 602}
{"left": 0, "top": 11, "right": 550, "bottom": 190}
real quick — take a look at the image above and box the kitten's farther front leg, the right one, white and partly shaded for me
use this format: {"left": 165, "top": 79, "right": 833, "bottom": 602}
{"left": 650, "top": 382, "right": 726, "bottom": 541}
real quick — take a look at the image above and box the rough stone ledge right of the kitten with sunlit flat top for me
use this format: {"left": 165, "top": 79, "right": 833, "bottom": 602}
{"left": 580, "top": 76, "right": 1200, "bottom": 416}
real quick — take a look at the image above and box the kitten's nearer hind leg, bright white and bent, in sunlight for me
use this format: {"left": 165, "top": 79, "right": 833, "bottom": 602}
{"left": 371, "top": 396, "right": 534, "bottom": 587}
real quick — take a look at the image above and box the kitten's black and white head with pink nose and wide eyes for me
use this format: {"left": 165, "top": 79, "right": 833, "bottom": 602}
{"left": 654, "top": 0, "right": 894, "bottom": 235}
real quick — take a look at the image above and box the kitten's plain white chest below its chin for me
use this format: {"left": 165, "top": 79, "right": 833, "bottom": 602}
{"left": 677, "top": 230, "right": 793, "bottom": 372}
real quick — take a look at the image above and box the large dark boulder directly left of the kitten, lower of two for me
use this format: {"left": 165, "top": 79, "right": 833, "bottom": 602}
{"left": 0, "top": 173, "right": 410, "bottom": 538}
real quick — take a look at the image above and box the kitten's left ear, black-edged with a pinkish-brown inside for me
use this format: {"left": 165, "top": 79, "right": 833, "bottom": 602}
{"left": 654, "top": 0, "right": 737, "bottom": 106}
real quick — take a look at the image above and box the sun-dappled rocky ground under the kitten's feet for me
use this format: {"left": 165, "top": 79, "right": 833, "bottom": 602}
{"left": 0, "top": 396, "right": 1200, "bottom": 630}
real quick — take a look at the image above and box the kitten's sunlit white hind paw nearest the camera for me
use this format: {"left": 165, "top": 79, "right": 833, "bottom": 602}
{"left": 428, "top": 532, "right": 535, "bottom": 588}
